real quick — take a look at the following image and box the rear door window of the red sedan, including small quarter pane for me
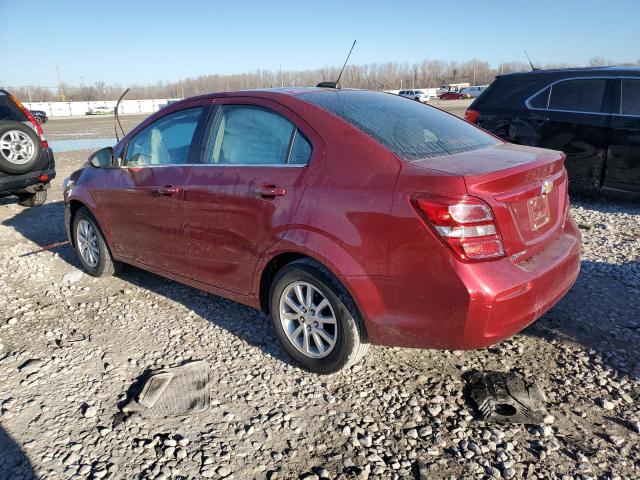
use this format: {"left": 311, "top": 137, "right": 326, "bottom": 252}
{"left": 207, "top": 105, "right": 311, "bottom": 165}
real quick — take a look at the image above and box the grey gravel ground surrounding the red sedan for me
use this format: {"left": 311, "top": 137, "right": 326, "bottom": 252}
{"left": 0, "top": 113, "right": 640, "bottom": 479}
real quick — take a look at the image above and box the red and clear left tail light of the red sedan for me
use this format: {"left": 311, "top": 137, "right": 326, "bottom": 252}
{"left": 413, "top": 196, "right": 505, "bottom": 261}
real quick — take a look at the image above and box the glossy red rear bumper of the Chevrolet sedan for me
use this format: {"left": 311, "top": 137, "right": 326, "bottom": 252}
{"left": 343, "top": 217, "right": 581, "bottom": 350}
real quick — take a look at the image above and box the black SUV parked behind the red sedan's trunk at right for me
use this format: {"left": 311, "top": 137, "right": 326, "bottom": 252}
{"left": 465, "top": 67, "right": 640, "bottom": 193}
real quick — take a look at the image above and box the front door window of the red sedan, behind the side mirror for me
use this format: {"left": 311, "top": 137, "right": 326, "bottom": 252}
{"left": 124, "top": 107, "right": 203, "bottom": 167}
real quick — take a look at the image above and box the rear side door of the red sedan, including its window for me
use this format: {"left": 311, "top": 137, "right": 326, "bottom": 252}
{"left": 184, "top": 97, "right": 323, "bottom": 294}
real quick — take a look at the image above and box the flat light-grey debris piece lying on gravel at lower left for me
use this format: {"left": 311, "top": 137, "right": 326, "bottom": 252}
{"left": 122, "top": 360, "right": 211, "bottom": 418}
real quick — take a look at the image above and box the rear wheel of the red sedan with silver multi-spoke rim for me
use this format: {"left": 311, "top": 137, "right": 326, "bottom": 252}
{"left": 270, "top": 260, "right": 369, "bottom": 374}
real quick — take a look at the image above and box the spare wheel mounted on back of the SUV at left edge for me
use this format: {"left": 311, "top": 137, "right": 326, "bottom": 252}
{"left": 0, "top": 121, "right": 41, "bottom": 175}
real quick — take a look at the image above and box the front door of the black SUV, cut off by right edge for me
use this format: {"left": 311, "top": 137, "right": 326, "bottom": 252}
{"left": 604, "top": 78, "right": 640, "bottom": 191}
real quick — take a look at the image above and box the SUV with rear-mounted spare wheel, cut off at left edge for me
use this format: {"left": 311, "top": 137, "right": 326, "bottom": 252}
{"left": 0, "top": 90, "right": 56, "bottom": 207}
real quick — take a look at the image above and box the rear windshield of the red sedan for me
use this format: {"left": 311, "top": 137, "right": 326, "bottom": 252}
{"left": 300, "top": 90, "right": 500, "bottom": 161}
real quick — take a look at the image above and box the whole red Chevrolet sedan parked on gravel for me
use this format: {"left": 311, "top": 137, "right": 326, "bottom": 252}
{"left": 64, "top": 88, "right": 580, "bottom": 373}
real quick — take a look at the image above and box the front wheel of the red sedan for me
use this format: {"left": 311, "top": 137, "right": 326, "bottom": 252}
{"left": 71, "top": 207, "right": 120, "bottom": 277}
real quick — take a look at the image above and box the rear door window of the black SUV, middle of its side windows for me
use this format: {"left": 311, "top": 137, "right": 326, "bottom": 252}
{"left": 549, "top": 78, "right": 607, "bottom": 113}
